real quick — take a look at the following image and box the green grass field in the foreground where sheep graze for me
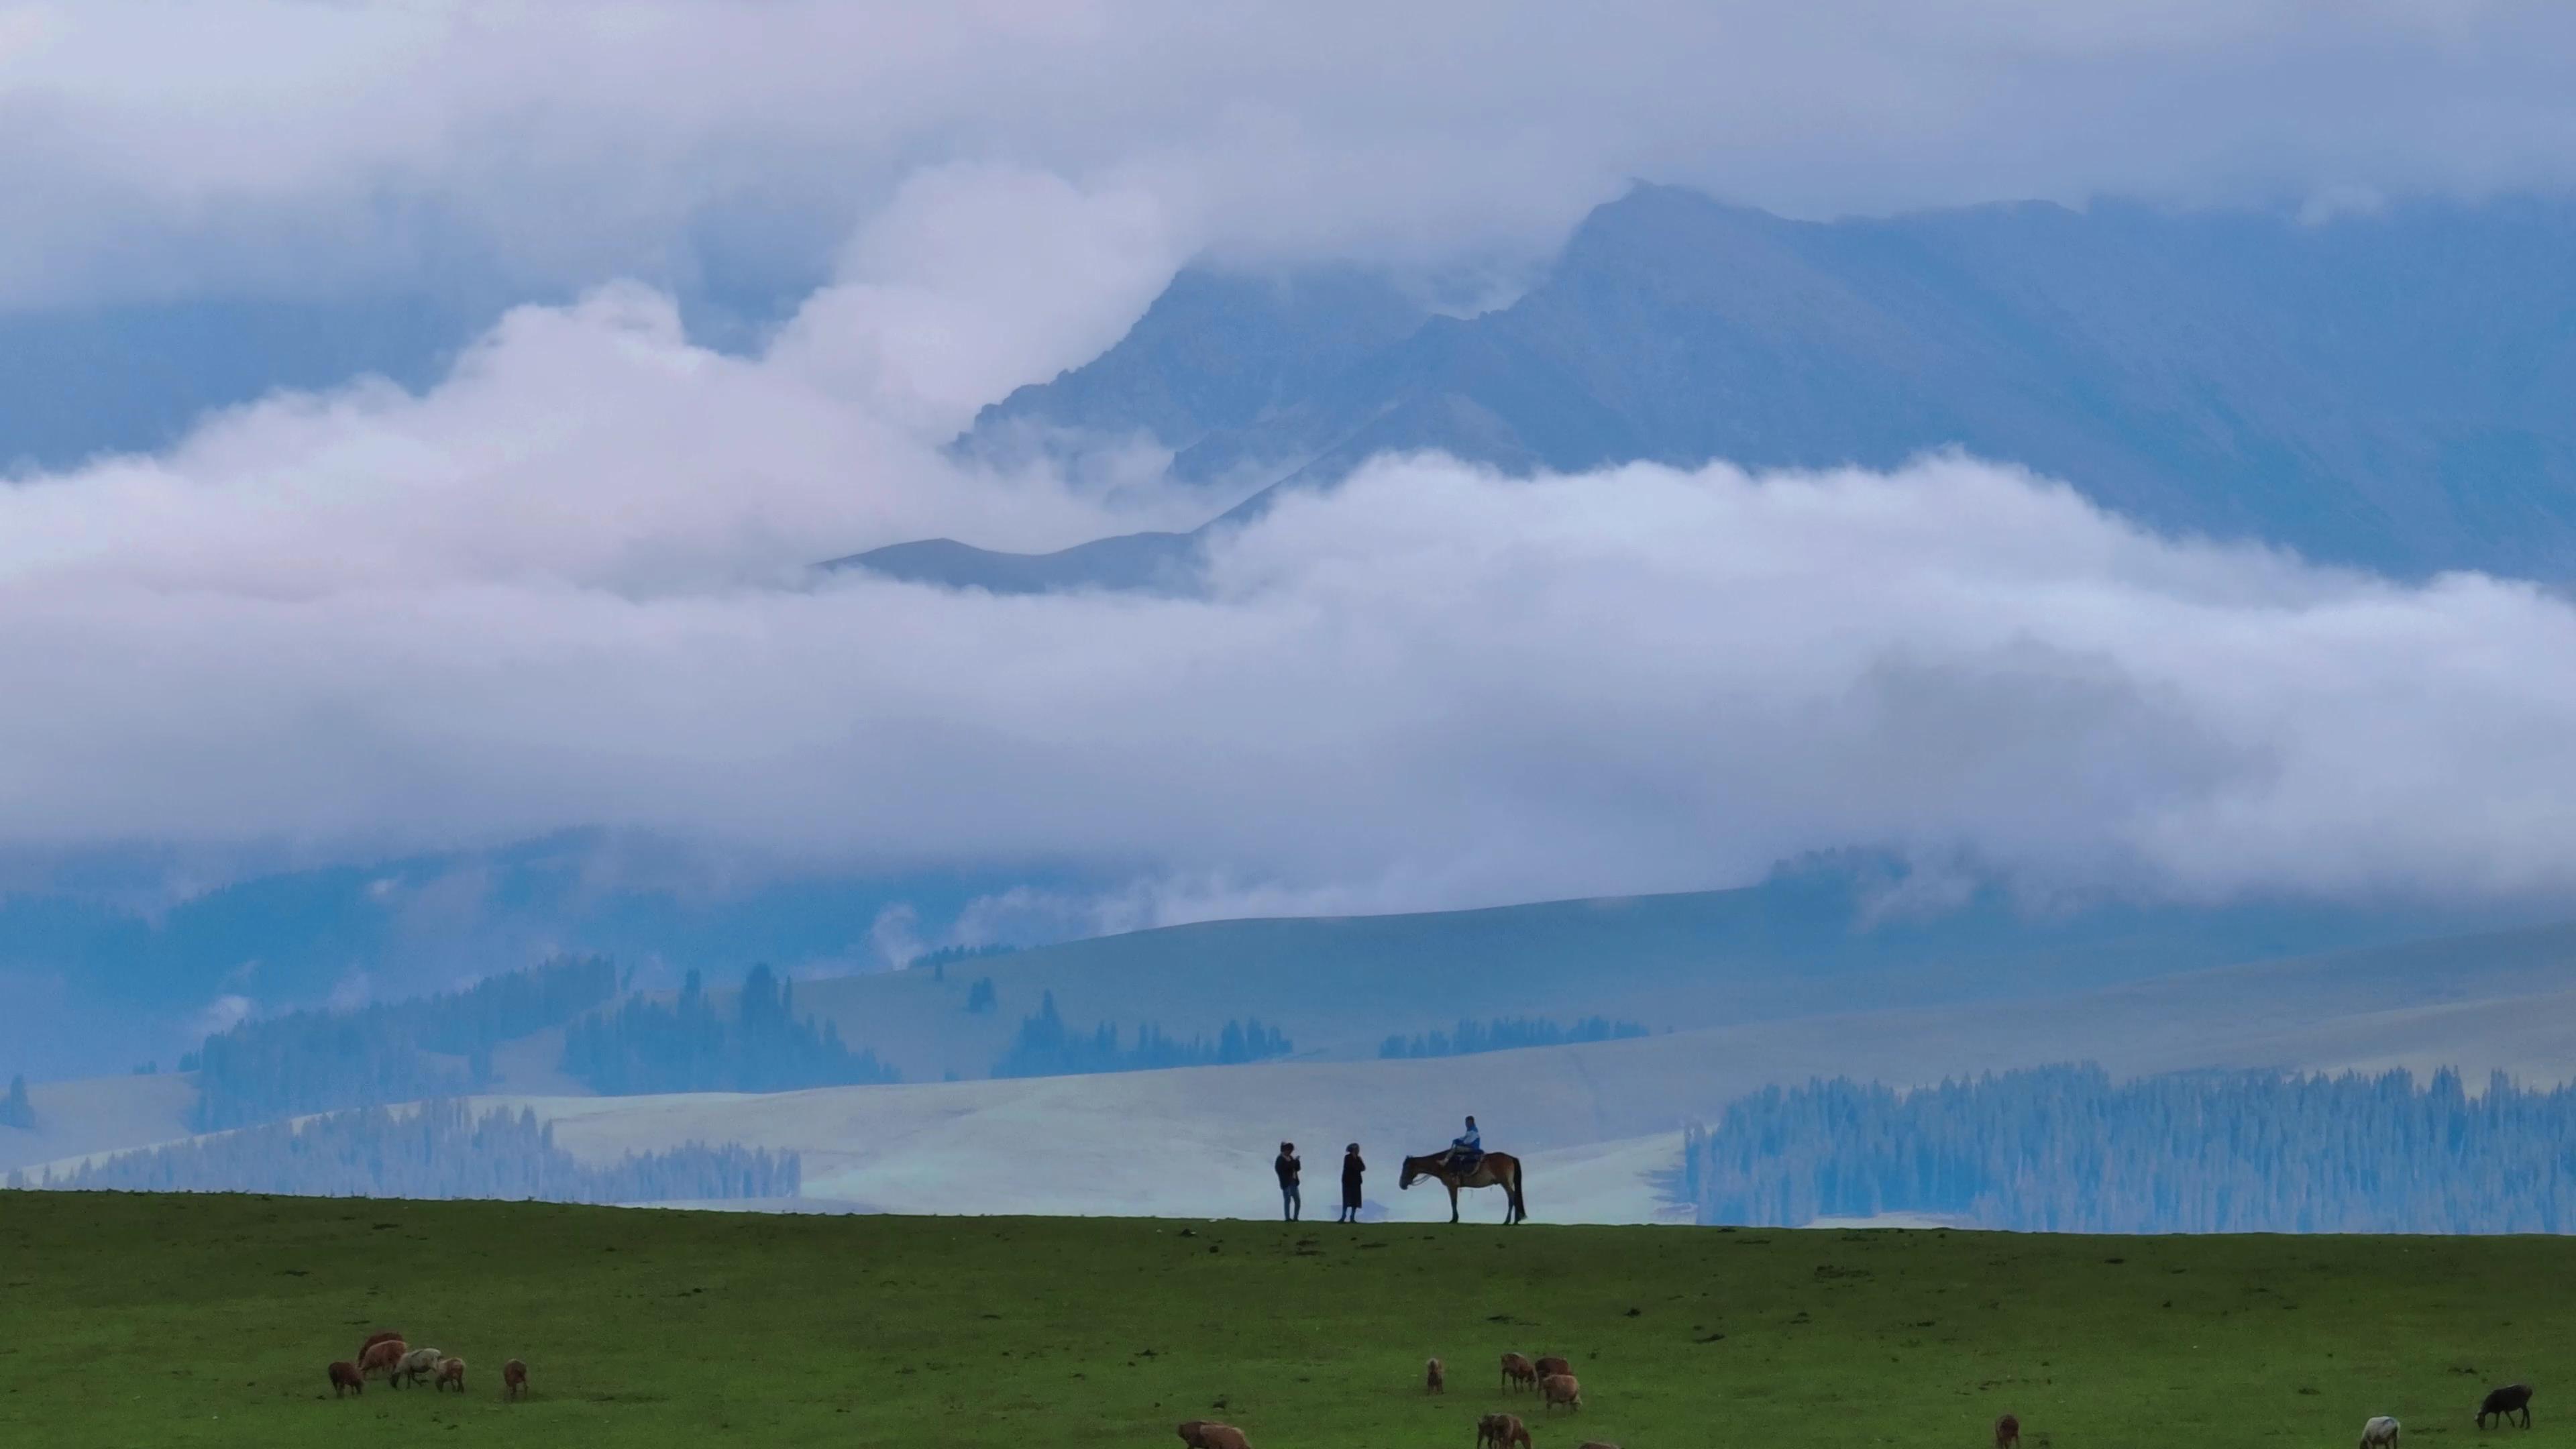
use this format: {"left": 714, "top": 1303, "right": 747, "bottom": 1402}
{"left": 0, "top": 1194, "right": 2576, "bottom": 1449}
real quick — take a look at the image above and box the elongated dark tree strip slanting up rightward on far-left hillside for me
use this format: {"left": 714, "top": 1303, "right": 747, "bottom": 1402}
{"left": 191, "top": 957, "right": 619, "bottom": 1132}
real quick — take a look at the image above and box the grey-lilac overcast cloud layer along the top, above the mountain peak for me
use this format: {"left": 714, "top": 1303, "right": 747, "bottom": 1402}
{"left": 0, "top": 0, "right": 2576, "bottom": 305}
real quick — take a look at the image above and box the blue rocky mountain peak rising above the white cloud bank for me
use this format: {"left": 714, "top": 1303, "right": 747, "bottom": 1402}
{"left": 861, "top": 186, "right": 2576, "bottom": 590}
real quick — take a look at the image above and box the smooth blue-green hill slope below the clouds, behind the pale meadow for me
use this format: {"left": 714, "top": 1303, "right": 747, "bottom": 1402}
{"left": 796, "top": 866, "right": 2504, "bottom": 1083}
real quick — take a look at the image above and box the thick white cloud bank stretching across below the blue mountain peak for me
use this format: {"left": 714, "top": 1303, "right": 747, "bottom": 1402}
{"left": 0, "top": 246, "right": 2576, "bottom": 923}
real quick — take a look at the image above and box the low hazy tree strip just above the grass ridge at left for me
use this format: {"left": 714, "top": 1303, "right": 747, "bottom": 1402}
{"left": 8, "top": 1101, "right": 804, "bottom": 1201}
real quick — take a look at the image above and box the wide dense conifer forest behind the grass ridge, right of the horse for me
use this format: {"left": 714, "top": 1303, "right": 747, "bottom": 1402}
{"left": 1682, "top": 1065, "right": 2576, "bottom": 1232}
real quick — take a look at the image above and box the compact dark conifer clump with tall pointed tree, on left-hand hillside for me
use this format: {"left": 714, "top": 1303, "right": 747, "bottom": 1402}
{"left": 564, "top": 967, "right": 902, "bottom": 1095}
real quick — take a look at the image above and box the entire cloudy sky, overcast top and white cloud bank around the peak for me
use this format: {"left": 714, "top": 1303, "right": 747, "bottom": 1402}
{"left": 0, "top": 0, "right": 2576, "bottom": 949}
